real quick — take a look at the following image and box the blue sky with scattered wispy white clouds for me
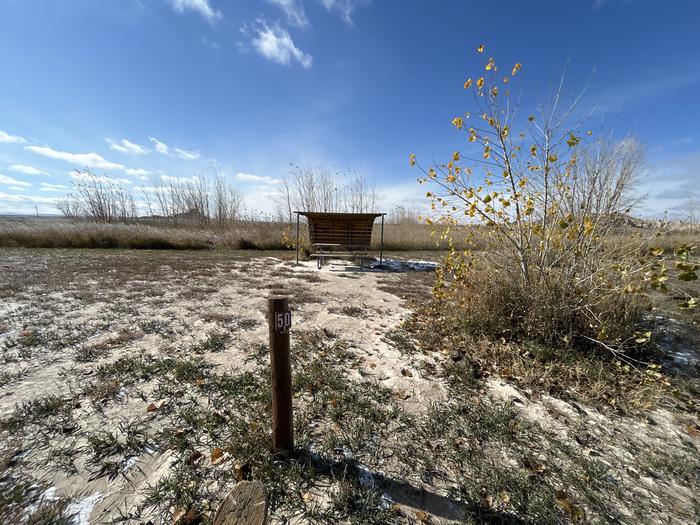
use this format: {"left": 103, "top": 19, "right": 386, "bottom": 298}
{"left": 0, "top": 0, "right": 700, "bottom": 215}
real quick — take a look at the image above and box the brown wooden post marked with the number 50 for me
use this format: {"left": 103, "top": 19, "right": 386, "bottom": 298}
{"left": 267, "top": 296, "right": 294, "bottom": 455}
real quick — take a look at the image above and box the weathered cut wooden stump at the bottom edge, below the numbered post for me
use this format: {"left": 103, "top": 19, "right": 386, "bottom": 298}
{"left": 214, "top": 481, "right": 267, "bottom": 525}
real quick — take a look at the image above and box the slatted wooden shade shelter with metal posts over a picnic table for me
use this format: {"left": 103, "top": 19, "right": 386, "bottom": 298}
{"left": 294, "top": 211, "right": 386, "bottom": 269}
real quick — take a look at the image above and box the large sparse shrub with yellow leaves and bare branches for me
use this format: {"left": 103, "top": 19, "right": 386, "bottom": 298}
{"left": 410, "top": 47, "right": 697, "bottom": 352}
